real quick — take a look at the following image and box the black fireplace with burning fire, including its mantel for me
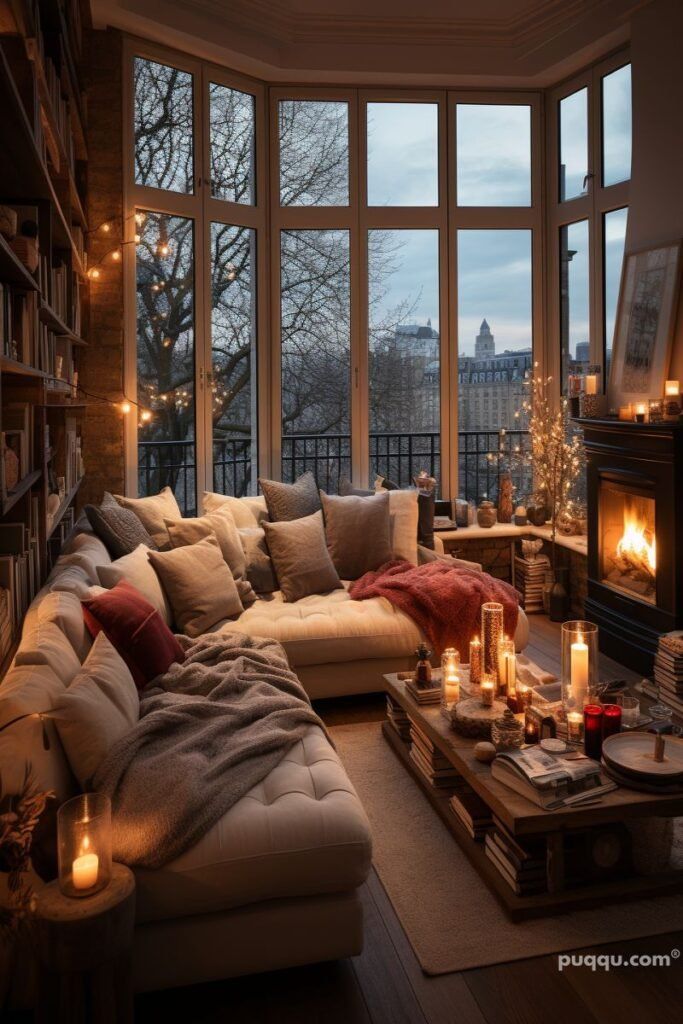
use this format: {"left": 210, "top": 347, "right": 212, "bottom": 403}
{"left": 579, "top": 420, "right": 683, "bottom": 674}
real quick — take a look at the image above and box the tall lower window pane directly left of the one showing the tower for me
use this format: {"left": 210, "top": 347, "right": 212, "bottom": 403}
{"left": 368, "top": 230, "right": 440, "bottom": 486}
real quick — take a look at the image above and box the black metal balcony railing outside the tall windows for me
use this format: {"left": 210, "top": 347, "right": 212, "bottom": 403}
{"left": 138, "top": 430, "right": 531, "bottom": 512}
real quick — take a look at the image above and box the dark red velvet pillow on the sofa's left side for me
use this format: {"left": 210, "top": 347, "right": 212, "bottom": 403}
{"left": 81, "top": 580, "right": 185, "bottom": 689}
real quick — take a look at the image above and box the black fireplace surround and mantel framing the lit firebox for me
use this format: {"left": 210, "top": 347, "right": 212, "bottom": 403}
{"left": 577, "top": 419, "right": 683, "bottom": 675}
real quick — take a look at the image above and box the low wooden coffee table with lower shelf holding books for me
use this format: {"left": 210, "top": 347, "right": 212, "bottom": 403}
{"left": 383, "top": 674, "right": 683, "bottom": 921}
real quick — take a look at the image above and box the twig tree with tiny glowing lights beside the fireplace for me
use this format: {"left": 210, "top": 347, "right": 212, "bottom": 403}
{"left": 515, "top": 362, "right": 585, "bottom": 571}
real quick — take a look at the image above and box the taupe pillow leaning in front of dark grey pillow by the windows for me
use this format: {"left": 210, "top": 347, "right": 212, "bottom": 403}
{"left": 263, "top": 512, "right": 342, "bottom": 601}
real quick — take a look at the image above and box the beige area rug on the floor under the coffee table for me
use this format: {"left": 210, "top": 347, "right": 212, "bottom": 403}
{"left": 330, "top": 722, "right": 683, "bottom": 975}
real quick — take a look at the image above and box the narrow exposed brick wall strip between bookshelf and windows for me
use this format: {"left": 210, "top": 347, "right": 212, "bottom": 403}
{"left": 79, "top": 30, "right": 125, "bottom": 504}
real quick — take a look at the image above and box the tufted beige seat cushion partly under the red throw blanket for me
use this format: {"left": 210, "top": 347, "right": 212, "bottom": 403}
{"left": 218, "top": 589, "right": 423, "bottom": 669}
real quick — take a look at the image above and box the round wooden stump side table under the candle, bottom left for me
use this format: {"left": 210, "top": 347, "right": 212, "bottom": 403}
{"left": 35, "top": 864, "right": 135, "bottom": 1024}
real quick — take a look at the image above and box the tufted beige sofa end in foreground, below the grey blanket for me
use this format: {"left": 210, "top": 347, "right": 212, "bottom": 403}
{"left": 135, "top": 726, "right": 372, "bottom": 922}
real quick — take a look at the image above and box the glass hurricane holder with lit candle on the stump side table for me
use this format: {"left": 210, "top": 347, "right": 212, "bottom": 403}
{"left": 57, "top": 793, "right": 112, "bottom": 897}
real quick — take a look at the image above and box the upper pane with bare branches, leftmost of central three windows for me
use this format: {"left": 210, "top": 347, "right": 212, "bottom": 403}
{"left": 280, "top": 99, "right": 348, "bottom": 206}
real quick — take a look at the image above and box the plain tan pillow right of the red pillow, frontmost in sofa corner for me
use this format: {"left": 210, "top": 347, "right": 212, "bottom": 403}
{"left": 150, "top": 537, "right": 244, "bottom": 637}
